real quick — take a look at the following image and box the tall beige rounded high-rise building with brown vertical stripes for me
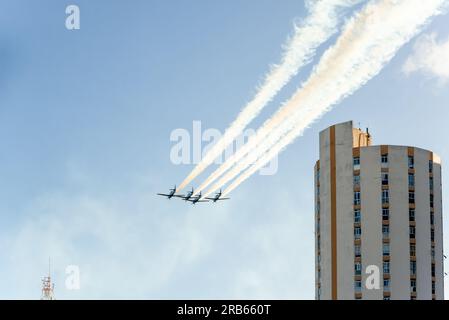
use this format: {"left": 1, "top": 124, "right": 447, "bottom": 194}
{"left": 315, "top": 122, "right": 444, "bottom": 300}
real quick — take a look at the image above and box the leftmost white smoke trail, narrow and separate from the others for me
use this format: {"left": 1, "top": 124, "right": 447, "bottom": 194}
{"left": 177, "top": 0, "right": 363, "bottom": 193}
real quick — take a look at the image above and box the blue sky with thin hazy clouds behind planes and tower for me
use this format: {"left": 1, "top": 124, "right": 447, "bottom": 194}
{"left": 0, "top": 0, "right": 449, "bottom": 299}
